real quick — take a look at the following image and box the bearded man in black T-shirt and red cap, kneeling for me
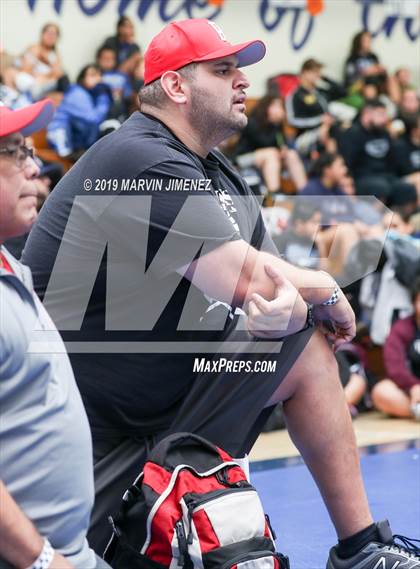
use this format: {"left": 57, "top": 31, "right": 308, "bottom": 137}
{"left": 23, "top": 19, "right": 416, "bottom": 569}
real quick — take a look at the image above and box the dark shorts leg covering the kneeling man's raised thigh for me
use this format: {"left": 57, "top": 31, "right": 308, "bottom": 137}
{"left": 165, "top": 329, "right": 313, "bottom": 458}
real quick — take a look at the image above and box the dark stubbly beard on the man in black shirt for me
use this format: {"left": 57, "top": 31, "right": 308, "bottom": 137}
{"left": 189, "top": 85, "right": 248, "bottom": 145}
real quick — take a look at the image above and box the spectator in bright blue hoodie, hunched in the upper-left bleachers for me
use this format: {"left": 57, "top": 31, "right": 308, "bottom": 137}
{"left": 47, "top": 64, "right": 112, "bottom": 158}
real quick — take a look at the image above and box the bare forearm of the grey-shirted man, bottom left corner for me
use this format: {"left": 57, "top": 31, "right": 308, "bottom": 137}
{"left": 0, "top": 481, "right": 44, "bottom": 569}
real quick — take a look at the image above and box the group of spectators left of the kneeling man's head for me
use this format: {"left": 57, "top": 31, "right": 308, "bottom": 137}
{"left": 0, "top": 16, "right": 143, "bottom": 156}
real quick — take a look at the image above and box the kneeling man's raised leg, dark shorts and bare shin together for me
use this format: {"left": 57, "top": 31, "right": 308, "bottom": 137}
{"left": 171, "top": 324, "right": 372, "bottom": 539}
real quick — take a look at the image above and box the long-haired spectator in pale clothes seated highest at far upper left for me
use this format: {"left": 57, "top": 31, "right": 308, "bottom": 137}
{"left": 9, "top": 23, "right": 69, "bottom": 100}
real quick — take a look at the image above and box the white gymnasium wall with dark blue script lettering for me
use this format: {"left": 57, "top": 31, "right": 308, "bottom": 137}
{"left": 0, "top": 0, "right": 420, "bottom": 97}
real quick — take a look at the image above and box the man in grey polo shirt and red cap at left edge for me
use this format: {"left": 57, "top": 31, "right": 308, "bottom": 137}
{"left": 0, "top": 100, "right": 109, "bottom": 569}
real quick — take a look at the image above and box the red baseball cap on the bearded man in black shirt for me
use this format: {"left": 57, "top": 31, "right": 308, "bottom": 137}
{"left": 144, "top": 18, "right": 266, "bottom": 85}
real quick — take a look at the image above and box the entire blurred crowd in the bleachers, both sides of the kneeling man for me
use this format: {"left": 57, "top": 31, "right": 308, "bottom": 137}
{"left": 0, "top": 22, "right": 420, "bottom": 419}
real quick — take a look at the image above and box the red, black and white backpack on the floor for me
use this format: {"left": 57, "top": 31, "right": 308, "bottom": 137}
{"left": 104, "top": 433, "right": 289, "bottom": 569}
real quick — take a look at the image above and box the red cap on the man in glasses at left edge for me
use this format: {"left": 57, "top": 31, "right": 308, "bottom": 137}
{"left": 0, "top": 99, "right": 54, "bottom": 136}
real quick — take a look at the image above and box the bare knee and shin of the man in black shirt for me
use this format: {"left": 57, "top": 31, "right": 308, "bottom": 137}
{"left": 269, "top": 331, "right": 372, "bottom": 539}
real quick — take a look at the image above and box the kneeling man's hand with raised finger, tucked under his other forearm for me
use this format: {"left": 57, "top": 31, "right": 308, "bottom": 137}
{"left": 247, "top": 265, "right": 308, "bottom": 339}
